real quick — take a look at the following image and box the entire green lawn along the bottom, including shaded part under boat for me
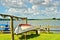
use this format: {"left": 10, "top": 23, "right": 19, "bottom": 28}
{"left": 0, "top": 34, "right": 60, "bottom": 40}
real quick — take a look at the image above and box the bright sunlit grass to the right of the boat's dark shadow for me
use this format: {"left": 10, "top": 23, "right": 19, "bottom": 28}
{"left": 29, "top": 34, "right": 60, "bottom": 40}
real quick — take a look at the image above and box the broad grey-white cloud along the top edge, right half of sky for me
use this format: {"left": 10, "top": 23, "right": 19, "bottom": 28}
{"left": 30, "top": 0, "right": 60, "bottom": 7}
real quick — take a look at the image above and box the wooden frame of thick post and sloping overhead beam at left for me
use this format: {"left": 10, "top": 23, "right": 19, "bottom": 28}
{"left": 0, "top": 14, "right": 27, "bottom": 40}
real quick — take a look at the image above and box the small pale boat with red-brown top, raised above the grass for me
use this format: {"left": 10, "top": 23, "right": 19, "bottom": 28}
{"left": 14, "top": 24, "right": 40, "bottom": 34}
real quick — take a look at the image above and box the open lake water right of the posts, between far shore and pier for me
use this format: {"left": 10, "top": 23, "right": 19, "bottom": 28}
{"left": 28, "top": 20, "right": 60, "bottom": 26}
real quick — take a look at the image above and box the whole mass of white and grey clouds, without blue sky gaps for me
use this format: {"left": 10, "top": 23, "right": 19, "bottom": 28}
{"left": 1, "top": 0, "right": 60, "bottom": 17}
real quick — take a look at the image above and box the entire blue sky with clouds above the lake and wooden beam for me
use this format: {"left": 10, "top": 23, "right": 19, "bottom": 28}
{"left": 0, "top": 0, "right": 60, "bottom": 19}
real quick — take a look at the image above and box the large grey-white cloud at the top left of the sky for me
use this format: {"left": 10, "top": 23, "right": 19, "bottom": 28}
{"left": 1, "top": 0, "right": 27, "bottom": 9}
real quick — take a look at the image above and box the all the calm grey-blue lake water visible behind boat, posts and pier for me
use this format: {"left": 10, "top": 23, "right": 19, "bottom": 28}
{"left": 0, "top": 20, "right": 60, "bottom": 33}
